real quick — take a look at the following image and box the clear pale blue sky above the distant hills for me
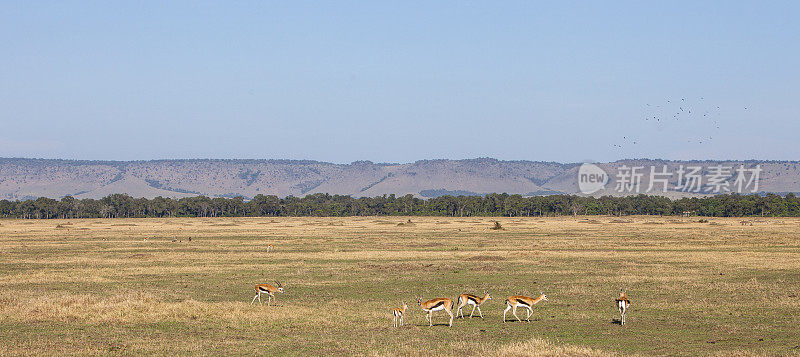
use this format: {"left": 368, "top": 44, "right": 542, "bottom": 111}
{"left": 0, "top": 1, "right": 800, "bottom": 163}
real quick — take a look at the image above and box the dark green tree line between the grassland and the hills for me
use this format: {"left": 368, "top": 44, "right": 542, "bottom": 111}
{"left": 0, "top": 193, "right": 800, "bottom": 219}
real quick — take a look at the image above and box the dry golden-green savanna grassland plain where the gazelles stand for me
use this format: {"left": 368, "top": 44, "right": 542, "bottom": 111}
{"left": 0, "top": 217, "right": 800, "bottom": 356}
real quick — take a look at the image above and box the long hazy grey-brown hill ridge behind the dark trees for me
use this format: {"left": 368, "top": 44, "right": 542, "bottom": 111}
{"left": 0, "top": 158, "right": 800, "bottom": 200}
